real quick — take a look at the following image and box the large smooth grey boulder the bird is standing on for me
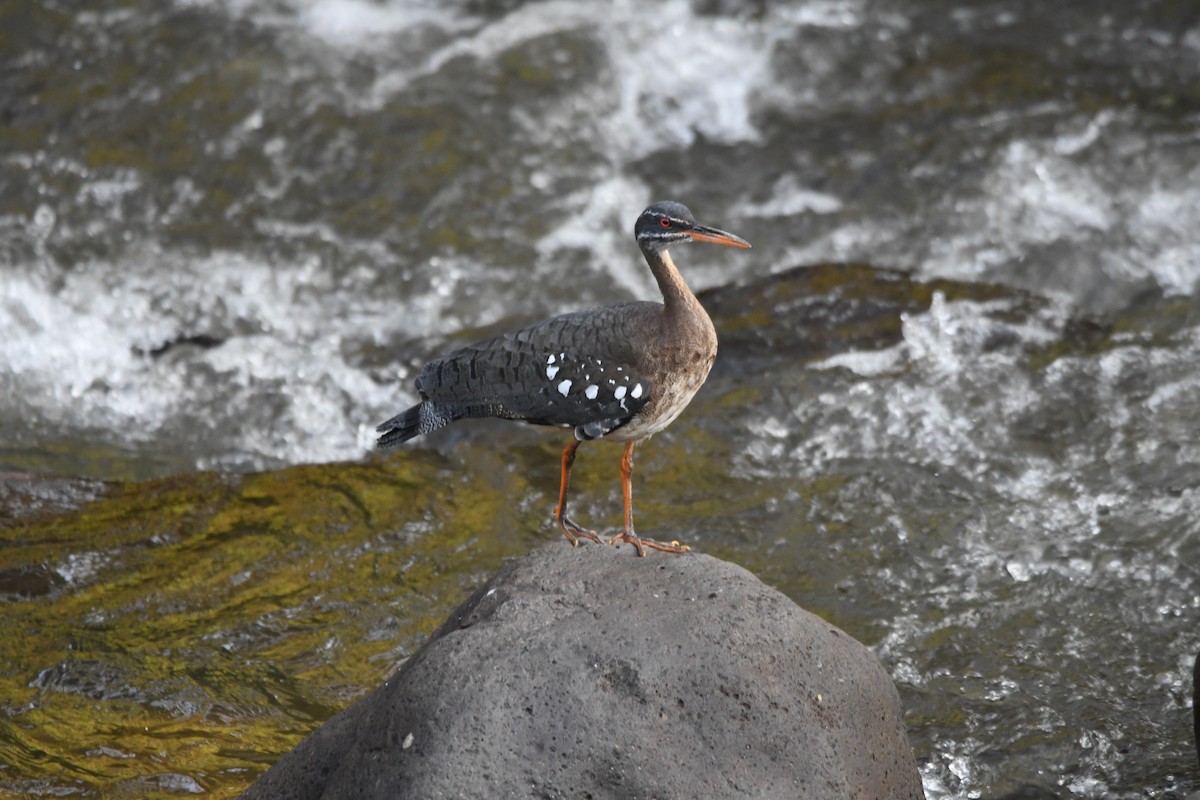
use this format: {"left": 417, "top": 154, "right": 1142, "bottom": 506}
{"left": 244, "top": 542, "right": 924, "bottom": 800}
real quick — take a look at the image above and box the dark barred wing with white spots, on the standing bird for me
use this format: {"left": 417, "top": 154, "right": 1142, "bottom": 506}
{"left": 416, "top": 302, "right": 661, "bottom": 438}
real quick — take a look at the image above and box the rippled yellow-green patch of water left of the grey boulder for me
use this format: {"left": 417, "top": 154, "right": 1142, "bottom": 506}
{"left": 0, "top": 453, "right": 520, "bottom": 796}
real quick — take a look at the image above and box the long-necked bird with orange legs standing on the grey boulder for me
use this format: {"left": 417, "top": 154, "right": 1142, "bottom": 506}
{"left": 377, "top": 201, "right": 750, "bottom": 557}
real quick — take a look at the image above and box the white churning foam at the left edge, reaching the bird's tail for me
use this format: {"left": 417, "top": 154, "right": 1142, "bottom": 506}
{"left": 0, "top": 245, "right": 461, "bottom": 467}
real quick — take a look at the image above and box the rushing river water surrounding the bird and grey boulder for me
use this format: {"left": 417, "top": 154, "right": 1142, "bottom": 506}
{"left": 0, "top": 0, "right": 1200, "bottom": 799}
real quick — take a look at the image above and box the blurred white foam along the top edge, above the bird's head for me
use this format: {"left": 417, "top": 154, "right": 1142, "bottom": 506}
{"left": 202, "top": 0, "right": 787, "bottom": 154}
